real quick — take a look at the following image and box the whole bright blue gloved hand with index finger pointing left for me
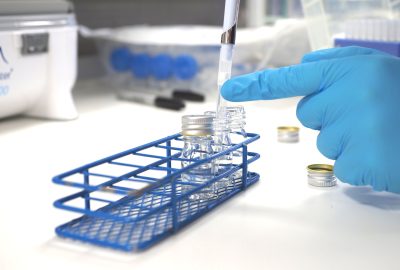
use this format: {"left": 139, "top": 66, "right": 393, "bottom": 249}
{"left": 221, "top": 47, "right": 400, "bottom": 193}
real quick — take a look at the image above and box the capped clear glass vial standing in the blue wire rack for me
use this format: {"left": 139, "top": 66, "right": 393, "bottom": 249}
{"left": 181, "top": 115, "right": 216, "bottom": 201}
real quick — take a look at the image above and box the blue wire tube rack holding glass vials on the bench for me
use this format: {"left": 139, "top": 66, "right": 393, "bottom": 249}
{"left": 53, "top": 133, "right": 260, "bottom": 251}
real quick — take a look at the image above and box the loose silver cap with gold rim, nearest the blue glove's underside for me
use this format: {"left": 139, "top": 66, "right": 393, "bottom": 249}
{"left": 307, "top": 164, "right": 337, "bottom": 187}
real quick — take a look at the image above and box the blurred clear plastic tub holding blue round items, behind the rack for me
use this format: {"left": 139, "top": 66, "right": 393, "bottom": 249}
{"left": 81, "top": 26, "right": 271, "bottom": 95}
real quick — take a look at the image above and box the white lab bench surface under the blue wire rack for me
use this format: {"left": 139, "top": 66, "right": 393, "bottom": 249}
{"left": 0, "top": 79, "right": 400, "bottom": 270}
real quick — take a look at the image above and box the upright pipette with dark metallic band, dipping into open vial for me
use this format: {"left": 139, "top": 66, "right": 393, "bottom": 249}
{"left": 217, "top": 0, "right": 240, "bottom": 112}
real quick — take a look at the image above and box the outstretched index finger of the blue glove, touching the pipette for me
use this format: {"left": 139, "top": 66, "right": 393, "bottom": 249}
{"left": 221, "top": 59, "right": 351, "bottom": 102}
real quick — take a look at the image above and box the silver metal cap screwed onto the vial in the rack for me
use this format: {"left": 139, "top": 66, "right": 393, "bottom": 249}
{"left": 182, "top": 115, "right": 214, "bottom": 136}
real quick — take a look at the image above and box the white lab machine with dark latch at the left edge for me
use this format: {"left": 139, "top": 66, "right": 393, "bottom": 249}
{"left": 0, "top": 0, "right": 77, "bottom": 120}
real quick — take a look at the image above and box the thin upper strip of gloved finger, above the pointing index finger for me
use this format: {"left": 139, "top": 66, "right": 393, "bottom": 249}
{"left": 301, "top": 46, "right": 388, "bottom": 63}
